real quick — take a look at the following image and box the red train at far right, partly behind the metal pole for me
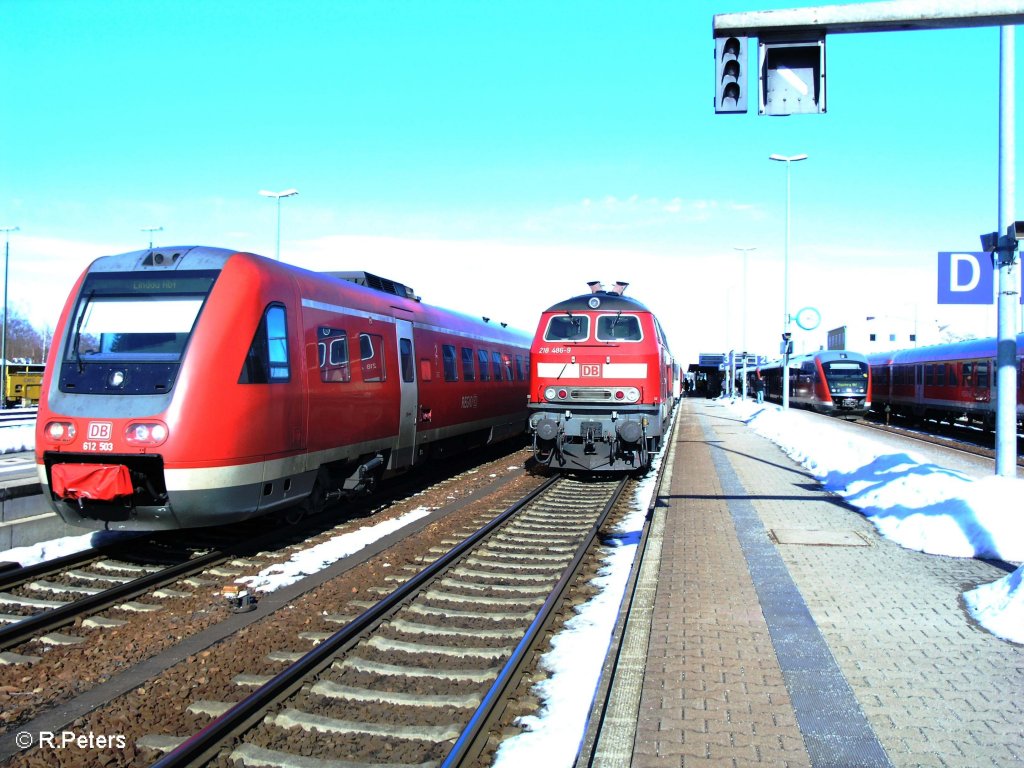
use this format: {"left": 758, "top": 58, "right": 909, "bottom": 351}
{"left": 868, "top": 335, "right": 1024, "bottom": 429}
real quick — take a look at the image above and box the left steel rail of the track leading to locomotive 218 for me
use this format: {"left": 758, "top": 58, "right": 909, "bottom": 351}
{"left": 151, "top": 475, "right": 560, "bottom": 768}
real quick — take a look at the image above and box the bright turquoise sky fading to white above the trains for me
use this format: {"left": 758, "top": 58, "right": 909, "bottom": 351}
{"left": 0, "top": 0, "right": 1024, "bottom": 361}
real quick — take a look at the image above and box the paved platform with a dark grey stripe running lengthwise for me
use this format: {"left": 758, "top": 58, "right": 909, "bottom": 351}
{"left": 592, "top": 398, "right": 1024, "bottom": 768}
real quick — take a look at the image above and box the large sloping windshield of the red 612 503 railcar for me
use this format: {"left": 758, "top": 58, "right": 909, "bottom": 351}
{"left": 60, "top": 270, "right": 219, "bottom": 394}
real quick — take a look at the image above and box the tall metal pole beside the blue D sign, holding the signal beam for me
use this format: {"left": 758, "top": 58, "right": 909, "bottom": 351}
{"left": 995, "top": 27, "right": 1019, "bottom": 477}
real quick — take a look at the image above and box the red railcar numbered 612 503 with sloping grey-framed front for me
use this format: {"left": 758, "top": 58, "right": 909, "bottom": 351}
{"left": 36, "top": 247, "right": 529, "bottom": 529}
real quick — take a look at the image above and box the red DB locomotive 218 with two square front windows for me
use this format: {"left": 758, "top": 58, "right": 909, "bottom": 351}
{"left": 529, "top": 283, "right": 678, "bottom": 472}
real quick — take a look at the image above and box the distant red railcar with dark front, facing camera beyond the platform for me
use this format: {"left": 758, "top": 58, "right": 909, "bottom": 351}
{"left": 748, "top": 349, "right": 871, "bottom": 416}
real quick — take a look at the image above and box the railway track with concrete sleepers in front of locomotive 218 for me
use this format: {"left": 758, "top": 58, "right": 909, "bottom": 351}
{"left": 144, "top": 477, "right": 628, "bottom": 768}
